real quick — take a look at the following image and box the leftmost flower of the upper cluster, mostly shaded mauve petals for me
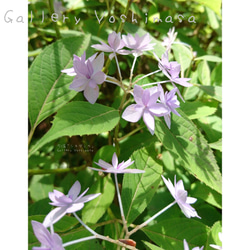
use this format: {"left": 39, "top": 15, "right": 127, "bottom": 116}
{"left": 62, "top": 52, "right": 106, "bottom": 104}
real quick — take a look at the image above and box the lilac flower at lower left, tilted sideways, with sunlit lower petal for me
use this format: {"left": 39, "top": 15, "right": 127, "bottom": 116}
{"left": 43, "top": 181, "right": 100, "bottom": 227}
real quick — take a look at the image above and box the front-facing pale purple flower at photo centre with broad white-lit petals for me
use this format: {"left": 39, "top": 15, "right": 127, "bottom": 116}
{"left": 122, "top": 85, "right": 170, "bottom": 135}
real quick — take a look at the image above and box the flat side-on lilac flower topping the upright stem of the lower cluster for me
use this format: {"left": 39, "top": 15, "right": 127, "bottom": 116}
{"left": 89, "top": 153, "right": 145, "bottom": 174}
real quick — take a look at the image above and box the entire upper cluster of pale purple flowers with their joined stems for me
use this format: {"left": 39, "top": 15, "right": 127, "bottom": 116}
{"left": 62, "top": 29, "right": 192, "bottom": 135}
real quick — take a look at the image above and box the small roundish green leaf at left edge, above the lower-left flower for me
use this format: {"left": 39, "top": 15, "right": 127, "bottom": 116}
{"left": 29, "top": 174, "right": 54, "bottom": 201}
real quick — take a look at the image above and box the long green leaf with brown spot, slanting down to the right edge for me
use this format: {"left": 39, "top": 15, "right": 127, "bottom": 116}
{"left": 155, "top": 110, "right": 222, "bottom": 193}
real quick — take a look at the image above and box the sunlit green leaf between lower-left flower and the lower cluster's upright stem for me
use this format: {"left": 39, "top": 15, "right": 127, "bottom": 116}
{"left": 82, "top": 175, "right": 115, "bottom": 224}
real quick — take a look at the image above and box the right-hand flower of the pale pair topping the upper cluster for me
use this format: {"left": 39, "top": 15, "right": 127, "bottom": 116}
{"left": 122, "top": 33, "right": 155, "bottom": 56}
